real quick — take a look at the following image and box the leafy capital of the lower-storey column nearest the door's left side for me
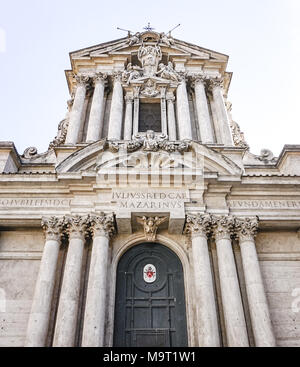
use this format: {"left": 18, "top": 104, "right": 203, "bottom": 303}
{"left": 90, "top": 213, "right": 116, "bottom": 238}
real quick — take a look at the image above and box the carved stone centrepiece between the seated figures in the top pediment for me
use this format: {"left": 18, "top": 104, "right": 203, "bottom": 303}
{"left": 138, "top": 45, "right": 162, "bottom": 77}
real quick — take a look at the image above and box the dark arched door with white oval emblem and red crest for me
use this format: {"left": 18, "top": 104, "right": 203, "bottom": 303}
{"left": 114, "top": 243, "right": 188, "bottom": 347}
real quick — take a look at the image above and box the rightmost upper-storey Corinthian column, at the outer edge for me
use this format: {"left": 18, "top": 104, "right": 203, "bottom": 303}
{"left": 210, "top": 79, "right": 233, "bottom": 145}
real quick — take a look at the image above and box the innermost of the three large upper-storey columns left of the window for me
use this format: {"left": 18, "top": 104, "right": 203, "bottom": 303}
{"left": 108, "top": 72, "right": 123, "bottom": 140}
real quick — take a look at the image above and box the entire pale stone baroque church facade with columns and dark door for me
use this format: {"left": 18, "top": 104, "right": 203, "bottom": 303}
{"left": 0, "top": 30, "right": 300, "bottom": 347}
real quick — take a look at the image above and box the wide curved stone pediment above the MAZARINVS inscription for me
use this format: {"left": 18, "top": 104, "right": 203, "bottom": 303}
{"left": 56, "top": 140, "right": 242, "bottom": 177}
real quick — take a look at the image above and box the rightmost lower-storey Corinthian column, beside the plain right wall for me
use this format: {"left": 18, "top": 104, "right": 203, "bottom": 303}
{"left": 236, "top": 218, "right": 276, "bottom": 347}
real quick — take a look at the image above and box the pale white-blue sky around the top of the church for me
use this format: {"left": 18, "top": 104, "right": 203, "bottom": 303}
{"left": 0, "top": 0, "right": 300, "bottom": 155}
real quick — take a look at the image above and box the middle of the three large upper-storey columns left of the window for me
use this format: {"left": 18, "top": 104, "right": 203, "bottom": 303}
{"left": 86, "top": 73, "right": 107, "bottom": 142}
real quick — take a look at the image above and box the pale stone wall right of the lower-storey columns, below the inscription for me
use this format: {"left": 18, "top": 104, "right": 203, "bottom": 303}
{"left": 256, "top": 231, "right": 300, "bottom": 347}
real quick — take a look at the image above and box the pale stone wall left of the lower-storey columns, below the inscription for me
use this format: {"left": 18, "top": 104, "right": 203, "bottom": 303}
{"left": 0, "top": 230, "right": 44, "bottom": 347}
